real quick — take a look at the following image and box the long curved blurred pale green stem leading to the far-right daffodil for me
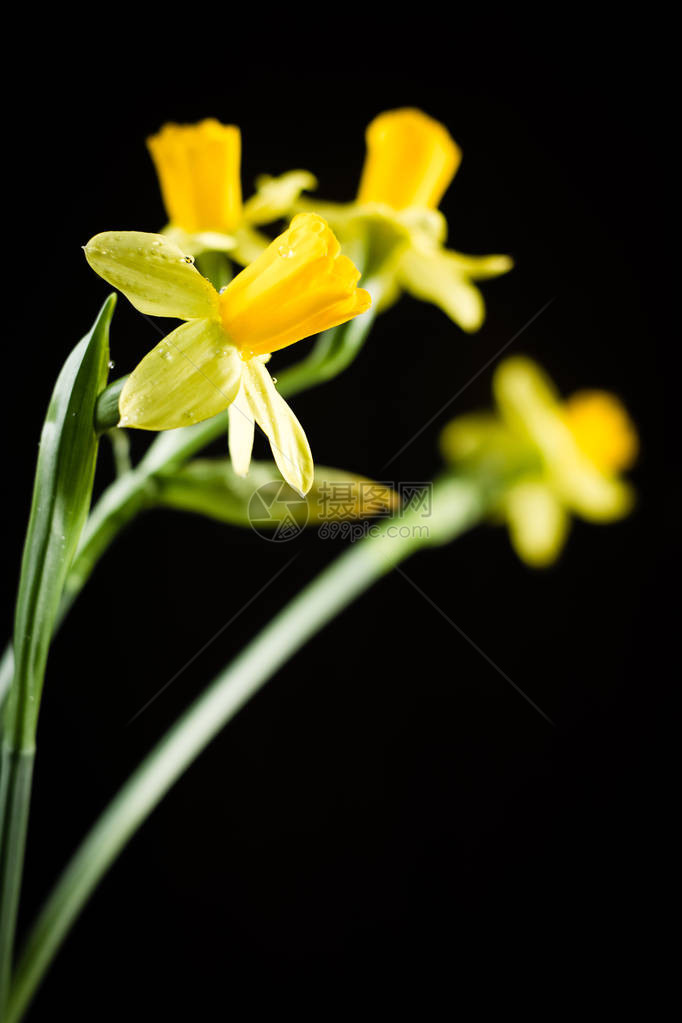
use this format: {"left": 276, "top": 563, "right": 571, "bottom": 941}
{"left": 5, "top": 478, "right": 486, "bottom": 1023}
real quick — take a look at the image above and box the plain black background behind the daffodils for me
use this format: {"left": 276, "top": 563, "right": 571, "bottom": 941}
{"left": 2, "top": 19, "right": 677, "bottom": 1021}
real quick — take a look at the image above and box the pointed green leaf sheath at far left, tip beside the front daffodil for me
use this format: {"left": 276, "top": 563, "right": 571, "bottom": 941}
{"left": 5, "top": 295, "right": 116, "bottom": 749}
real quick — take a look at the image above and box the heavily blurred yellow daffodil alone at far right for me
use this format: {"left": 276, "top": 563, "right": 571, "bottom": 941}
{"left": 442, "top": 357, "right": 638, "bottom": 566}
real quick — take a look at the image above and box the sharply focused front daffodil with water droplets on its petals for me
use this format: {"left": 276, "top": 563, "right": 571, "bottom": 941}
{"left": 85, "top": 214, "right": 371, "bottom": 494}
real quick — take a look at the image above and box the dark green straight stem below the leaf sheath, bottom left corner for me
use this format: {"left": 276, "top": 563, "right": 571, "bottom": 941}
{"left": 0, "top": 743, "right": 35, "bottom": 1017}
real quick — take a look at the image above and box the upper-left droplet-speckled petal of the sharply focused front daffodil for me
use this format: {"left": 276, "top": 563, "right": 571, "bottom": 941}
{"left": 85, "top": 231, "right": 218, "bottom": 319}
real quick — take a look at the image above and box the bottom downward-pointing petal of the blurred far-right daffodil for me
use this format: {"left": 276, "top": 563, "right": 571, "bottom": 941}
{"left": 505, "top": 481, "right": 570, "bottom": 568}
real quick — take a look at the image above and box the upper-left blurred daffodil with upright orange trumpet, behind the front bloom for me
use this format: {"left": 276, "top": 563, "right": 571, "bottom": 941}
{"left": 147, "top": 118, "right": 316, "bottom": 264}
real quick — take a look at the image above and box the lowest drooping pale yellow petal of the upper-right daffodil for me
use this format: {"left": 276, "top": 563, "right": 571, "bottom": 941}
{"left": 398, "top": 247, "right": 486, "bottom": 331}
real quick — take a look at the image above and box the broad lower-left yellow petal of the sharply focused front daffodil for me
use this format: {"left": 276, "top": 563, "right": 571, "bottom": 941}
{"left": 119, "top": 319, "right": 243, "bottom": 430}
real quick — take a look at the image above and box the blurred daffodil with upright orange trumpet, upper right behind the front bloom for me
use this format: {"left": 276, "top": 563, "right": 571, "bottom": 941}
{"left": 293, "top": 108, "right": 512, "bottom": 331}
